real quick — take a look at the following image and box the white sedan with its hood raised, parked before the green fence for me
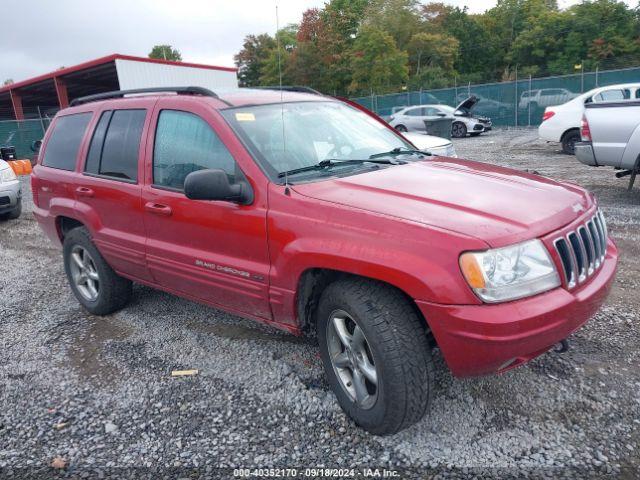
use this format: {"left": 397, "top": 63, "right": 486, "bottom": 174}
{"left": 389, "top": 95, "right": 492, "bottom": 138}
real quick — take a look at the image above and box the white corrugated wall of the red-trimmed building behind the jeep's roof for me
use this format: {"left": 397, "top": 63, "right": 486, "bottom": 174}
{"left": 116, "top": 58, "right": 238, "bottom": 91}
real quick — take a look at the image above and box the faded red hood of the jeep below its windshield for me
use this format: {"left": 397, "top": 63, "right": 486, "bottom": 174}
{"left": 294, "top": 157, "right": 593, "bottom": 247}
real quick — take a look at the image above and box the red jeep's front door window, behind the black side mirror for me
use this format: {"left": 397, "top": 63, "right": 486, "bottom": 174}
{"left": 153, "top": 110, "right": 236, "bottom": 190}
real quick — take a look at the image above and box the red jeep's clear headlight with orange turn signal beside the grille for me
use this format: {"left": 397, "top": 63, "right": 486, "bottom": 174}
{"left": 460, "top": 240, "right": 560, "bottom": 303}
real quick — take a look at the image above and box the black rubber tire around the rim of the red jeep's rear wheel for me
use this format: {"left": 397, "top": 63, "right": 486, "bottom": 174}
{"left": 63, "top": 227, "right": 132, "bottom": 315}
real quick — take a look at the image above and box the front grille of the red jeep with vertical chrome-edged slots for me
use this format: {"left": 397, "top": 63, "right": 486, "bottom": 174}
{"left": 553, "top": 210, "right": 608, "bottom": 289}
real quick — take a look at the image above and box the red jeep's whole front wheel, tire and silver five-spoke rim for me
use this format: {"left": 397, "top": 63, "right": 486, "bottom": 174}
{"left": 318, "top": 279, "right": 434, "bottom": 435}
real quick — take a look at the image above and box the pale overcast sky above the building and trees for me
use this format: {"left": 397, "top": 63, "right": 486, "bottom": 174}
{"left": 0, "top": 0, "right": 637, "bottom": 82}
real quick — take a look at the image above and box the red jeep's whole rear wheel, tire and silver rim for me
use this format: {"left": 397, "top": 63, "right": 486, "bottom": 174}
{"left": 63, "top": 227, "right": 131, "bottom": 315}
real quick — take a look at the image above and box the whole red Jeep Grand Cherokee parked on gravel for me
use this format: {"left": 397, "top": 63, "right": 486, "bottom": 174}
{"left": 31, "top": 87, "right": 617, "bottom": 434}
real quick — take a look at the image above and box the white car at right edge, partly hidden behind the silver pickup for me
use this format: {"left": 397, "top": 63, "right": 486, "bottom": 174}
{"left": 538, "top": 83, "right": 640, "bottom": 155}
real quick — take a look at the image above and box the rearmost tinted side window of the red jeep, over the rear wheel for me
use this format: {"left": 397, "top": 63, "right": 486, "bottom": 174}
{"left": 42, "top": 112, "right": 93, "bottom": 171}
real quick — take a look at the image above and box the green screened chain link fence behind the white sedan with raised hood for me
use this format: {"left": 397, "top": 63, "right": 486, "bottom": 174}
{"left": 352, "top": 67, "right": 640, "bottom": 127}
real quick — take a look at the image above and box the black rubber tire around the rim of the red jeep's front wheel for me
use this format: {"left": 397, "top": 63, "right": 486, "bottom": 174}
{"left": 317, "top": 279, "right": 434, "bottom": 435}
